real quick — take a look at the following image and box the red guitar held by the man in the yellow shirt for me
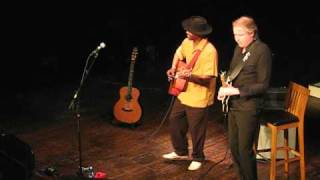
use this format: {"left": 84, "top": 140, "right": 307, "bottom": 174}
{"left": 168, "top": 60, "right": 188, "bottom": 96}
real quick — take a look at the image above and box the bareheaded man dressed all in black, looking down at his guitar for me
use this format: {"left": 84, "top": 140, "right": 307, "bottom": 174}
{"left": 218, "top": 16, "right": 272, "bottom": 180}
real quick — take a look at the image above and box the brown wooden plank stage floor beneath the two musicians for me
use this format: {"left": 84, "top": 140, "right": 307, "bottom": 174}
{"left": 3, "top": 78, "right": 320, "bottom": 180}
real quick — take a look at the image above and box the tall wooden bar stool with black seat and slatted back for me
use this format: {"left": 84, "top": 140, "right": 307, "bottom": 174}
{"left": 256, "top": 82, "right": 310, "bottom": 180}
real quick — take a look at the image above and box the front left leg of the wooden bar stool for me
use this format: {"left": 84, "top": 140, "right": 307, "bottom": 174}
{"left": 270, "top": 127, "right": 278, "bottom": 180}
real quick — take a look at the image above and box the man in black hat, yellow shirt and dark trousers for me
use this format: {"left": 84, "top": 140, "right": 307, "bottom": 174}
{"left": 162, "top": 16, "right": 218, "bottom": 170}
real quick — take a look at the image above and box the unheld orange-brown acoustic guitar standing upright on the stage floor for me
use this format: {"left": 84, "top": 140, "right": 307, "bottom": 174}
{"left": 113, "top": 47, "right": 142, "bottom": 124}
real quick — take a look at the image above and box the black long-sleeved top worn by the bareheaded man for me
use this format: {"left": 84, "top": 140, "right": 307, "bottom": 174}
{"left": 228, "top": 40, "right": 272, "bottom": 111}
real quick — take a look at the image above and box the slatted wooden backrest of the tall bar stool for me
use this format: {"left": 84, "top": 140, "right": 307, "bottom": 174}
{"left": 285, "top": 81, "right": 310, "bottom": 124}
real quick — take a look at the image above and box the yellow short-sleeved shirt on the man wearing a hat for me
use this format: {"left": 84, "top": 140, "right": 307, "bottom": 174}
{"left": 175, "top": 38, "right": 218, "bottom": 108}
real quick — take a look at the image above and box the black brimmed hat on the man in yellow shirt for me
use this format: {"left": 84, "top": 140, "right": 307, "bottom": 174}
{"left": 182, "top": 16, "right": 212, "bottom": 36}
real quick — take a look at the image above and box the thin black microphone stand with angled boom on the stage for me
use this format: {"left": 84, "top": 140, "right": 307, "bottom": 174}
{"left": 68, "top": 50, "right": 98, "bottom": 176}
